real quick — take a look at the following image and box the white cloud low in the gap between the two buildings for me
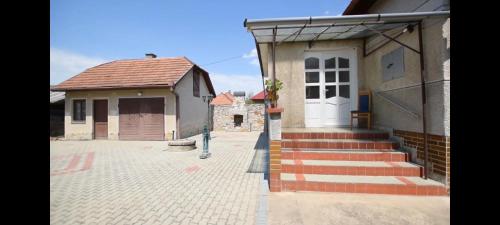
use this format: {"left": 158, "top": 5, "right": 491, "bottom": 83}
{"left": 210, "top": 73, "right": 263, "bottom": 94}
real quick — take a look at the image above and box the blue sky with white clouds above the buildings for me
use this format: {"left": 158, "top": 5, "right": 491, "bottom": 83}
{"left": 50, "top": 0, "right": 350, "bottom": 94}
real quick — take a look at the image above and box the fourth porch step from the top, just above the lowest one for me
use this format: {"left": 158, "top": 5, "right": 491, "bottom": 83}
{"left": 281, "top": 159, "right": 423, "bottom": 177}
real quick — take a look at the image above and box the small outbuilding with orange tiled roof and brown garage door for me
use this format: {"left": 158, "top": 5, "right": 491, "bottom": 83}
{"left": 52, "top": 54, "right": 215, "bottom": 140}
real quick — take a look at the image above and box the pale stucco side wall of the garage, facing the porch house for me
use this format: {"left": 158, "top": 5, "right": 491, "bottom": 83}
{"left": 175, "top": 67, "right": 210, "bottom": 138}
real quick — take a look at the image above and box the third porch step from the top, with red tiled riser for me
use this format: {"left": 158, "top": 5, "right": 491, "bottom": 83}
{"left": 281, "top": 148, "right": 408, "bottom": 162}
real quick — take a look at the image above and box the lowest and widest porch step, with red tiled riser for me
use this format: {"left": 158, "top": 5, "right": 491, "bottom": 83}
{"left": 281, "top": 173, "right": 447, "bottom": 195}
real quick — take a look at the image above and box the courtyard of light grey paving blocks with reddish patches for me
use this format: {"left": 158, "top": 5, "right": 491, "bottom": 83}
{"left": 50, "top": 132, "right": 267, "bottom": 224}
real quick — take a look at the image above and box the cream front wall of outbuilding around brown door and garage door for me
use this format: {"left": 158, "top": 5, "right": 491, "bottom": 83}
{"left": 64, "top": 89, "right": 176, "bottom": 140}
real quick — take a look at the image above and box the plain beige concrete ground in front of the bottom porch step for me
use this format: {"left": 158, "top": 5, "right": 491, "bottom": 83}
{"left": 268, "top": 192, "right": 450, "bottom": 225}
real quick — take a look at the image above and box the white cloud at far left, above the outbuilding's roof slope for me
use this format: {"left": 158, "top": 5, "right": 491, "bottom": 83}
{"left": 50, "top": 47, "right": 107, "bottom": 84}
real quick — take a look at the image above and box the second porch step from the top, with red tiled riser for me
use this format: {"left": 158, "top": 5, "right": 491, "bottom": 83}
{"left": 281, "top": 139, "right": 399, "bottom": 150}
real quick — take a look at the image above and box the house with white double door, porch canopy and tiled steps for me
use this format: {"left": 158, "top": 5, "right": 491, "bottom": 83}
{"left": 244, "top": 0, "right": 450, "bottom": 194}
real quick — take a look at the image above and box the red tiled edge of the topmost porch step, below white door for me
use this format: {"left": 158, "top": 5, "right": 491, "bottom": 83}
{"left": 281, "top": 132, "right": 389, "bottom": 139}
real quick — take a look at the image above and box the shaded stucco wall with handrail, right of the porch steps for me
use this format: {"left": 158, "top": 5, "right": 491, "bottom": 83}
{"left": 363, "top": 19, "right": 449, "bottom": 135}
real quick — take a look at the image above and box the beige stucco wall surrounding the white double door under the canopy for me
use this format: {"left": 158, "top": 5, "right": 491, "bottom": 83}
{"left": 267, "top": 40, "right": 364, "bottom": 127}
